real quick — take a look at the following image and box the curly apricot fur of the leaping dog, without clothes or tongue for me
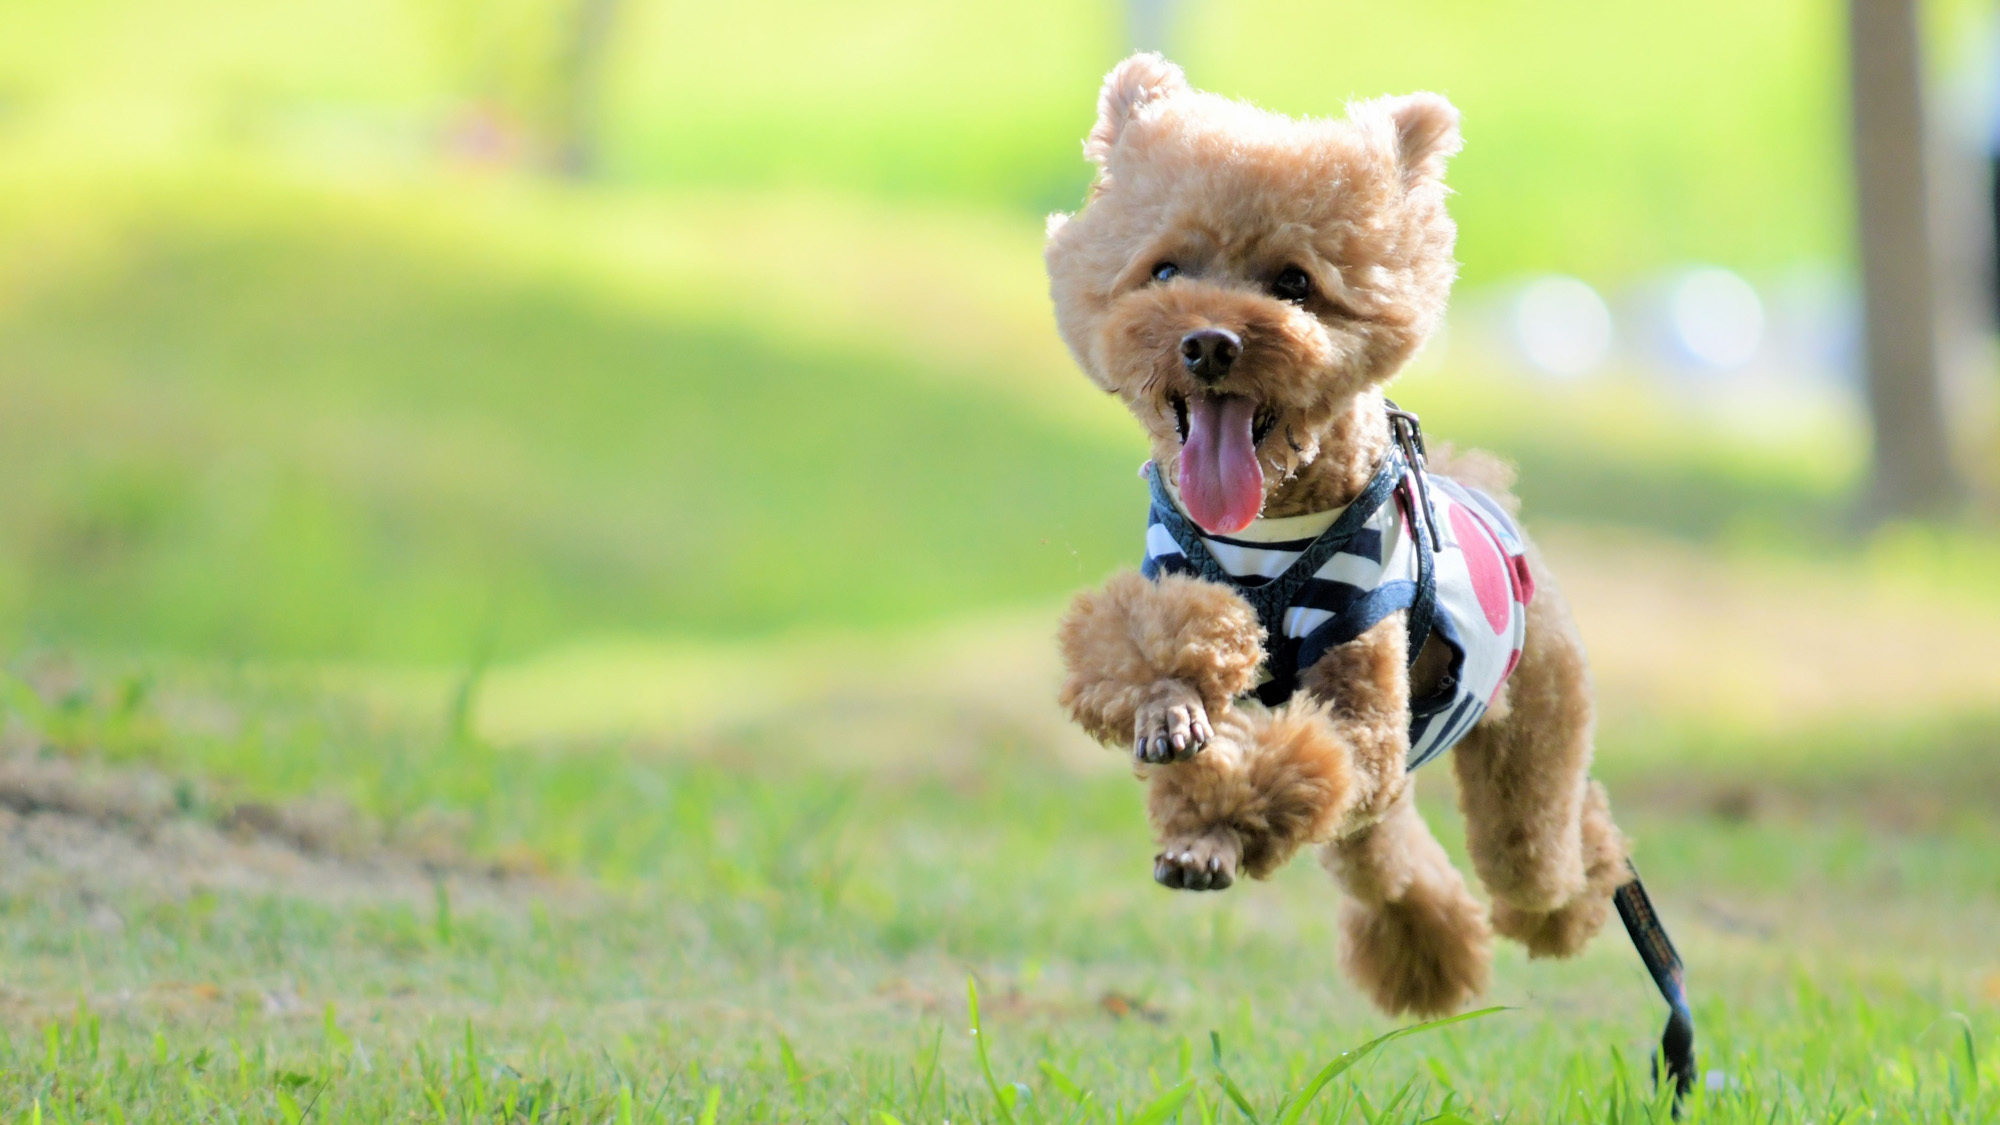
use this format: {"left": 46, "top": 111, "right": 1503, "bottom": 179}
{"left": 1046, "top": 54, "right": 1626, "bottom": 1015}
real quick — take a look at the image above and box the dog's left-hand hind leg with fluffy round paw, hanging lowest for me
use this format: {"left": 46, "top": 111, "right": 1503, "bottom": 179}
{"left": 1320, "top": 785, "right": 1492, "bottom": 1017}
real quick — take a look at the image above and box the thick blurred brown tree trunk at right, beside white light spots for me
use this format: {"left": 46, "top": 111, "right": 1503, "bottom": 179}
{"left": 1848, "top": 0, "right": 1962, "bottom": 518}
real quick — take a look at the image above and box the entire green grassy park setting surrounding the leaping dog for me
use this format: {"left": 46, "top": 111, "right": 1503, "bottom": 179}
{"left": 0, "top": 0, "right": 2000, "bottom": 1121}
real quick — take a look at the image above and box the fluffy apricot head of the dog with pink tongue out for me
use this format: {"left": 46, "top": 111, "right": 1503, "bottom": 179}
{"left": 1048, "top": 54, "right": 1458, "bottom": 532}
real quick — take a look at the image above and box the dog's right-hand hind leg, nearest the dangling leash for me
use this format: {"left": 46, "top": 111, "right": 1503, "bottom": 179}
{"left": 1452, "top": 550, "right": 1628, "bottom": 957}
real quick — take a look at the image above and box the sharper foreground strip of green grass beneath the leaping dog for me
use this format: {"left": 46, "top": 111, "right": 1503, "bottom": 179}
{"left": 0, "top": 655, "right": 2000, "bottom": 1123}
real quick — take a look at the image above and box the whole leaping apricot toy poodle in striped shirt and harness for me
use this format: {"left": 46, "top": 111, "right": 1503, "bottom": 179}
{"left": 1048, "top": 54, "right": 1640, "bottom": 1015}
